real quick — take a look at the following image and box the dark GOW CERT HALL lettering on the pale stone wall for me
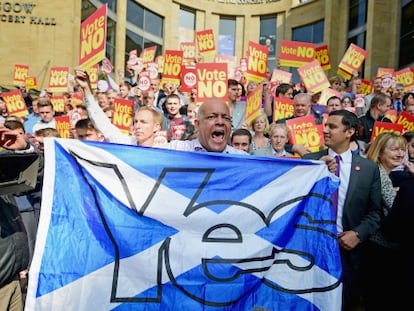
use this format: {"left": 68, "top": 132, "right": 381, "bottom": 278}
{"left": 0, "top": 1, "right": 56, "bottom": 26}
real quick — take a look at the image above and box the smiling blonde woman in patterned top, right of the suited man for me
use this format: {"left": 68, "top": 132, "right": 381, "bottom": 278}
{"left": 363, "top": 132, "right": 407, "bottom": 311}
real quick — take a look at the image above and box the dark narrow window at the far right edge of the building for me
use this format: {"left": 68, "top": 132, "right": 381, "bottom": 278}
{"left": 398, "top": 1, "right": 414, "bottom": 68}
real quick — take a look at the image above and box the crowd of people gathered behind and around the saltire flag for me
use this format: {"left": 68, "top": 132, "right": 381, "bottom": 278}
{"left": 0, "top": 62, "right": 414, "bottom": 311}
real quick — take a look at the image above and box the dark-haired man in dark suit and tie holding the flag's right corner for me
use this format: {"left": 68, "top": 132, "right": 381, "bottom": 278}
{"left": 303, "top": 110, "right": 381, "bottom": 310}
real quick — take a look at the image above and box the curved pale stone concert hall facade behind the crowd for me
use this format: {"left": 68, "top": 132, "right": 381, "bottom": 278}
{"left": 0, "top": 0, "right": 414, "bottom": 89}
